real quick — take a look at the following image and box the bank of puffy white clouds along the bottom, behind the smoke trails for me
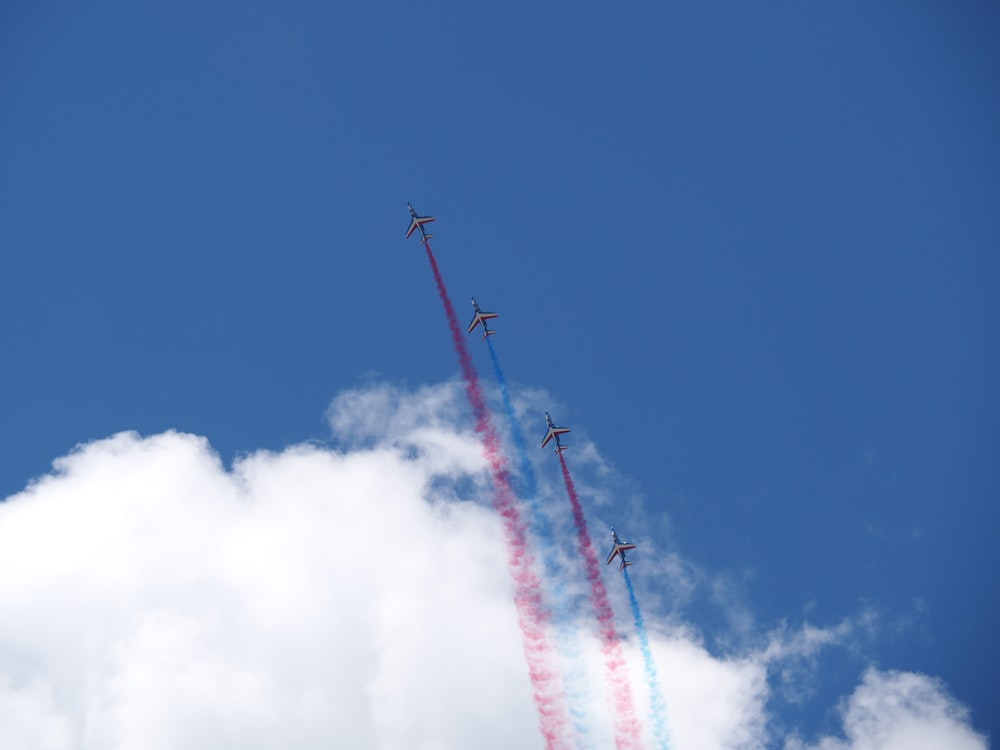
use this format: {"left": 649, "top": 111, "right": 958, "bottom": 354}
{"left": 0, "top": 383, "right": 982, "bottom": 750}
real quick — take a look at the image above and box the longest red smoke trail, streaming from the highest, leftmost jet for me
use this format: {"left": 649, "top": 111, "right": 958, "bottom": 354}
{"left": 424, "top": 239, "right": 569, "bottom": 750}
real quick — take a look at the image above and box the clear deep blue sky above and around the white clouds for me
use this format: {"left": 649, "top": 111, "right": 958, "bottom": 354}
{"left": 0, "top": 1, "right": 1000, "bottom": 748}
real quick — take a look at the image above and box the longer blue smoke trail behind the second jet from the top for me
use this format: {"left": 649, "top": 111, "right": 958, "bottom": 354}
{"left": 486, "top": 337, "right": 594, "bottom": 748}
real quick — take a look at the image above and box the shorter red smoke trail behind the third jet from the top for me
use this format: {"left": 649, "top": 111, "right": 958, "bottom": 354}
{"left": 559, "top": 453, "right": 641, "bottom": 750}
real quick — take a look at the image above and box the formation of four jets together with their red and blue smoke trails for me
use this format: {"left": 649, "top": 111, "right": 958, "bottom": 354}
{"left": 406, "top": 203, "right": 669, "bottom": 750}
